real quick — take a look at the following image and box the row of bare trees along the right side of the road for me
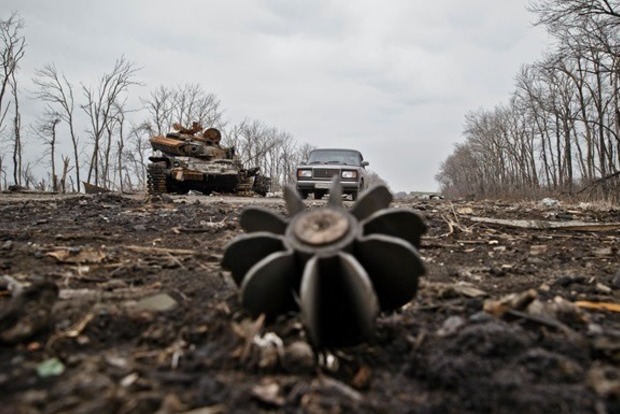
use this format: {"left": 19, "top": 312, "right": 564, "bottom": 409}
{"left": 435, "top": 0, "right": 620, "bottom": 201}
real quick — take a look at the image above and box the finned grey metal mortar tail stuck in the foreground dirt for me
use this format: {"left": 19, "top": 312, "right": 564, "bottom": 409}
{"left": 222, "top": 178, "right": 426, "bottom": 347}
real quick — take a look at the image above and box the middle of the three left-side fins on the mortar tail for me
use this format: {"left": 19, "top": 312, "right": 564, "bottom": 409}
{"left": 222, "top": 232, "right": 284, "bottom": 285}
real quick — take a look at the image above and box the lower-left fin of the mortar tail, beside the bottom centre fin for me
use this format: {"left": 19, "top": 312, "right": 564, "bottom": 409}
{"left": 241, "top": 247, "right": 301, "bottom": 318}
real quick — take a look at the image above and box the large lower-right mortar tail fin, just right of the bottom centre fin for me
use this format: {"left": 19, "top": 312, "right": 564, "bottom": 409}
{"left": 355, "top": 234, "right": 425, "bottom": 311}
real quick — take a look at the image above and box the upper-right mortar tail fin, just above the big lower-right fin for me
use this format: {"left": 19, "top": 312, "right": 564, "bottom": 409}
{"left": 361, "top": 208, "right": 426, "bottom": 248}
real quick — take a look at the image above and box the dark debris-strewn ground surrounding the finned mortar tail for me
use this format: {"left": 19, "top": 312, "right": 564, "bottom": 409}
{"left": 0, "top": 194, "right": 620, "bottom": 414}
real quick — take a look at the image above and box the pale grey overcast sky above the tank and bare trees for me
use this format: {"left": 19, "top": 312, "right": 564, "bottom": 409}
{"left": 6, "top": 0, "right": 547, "bottom": 191}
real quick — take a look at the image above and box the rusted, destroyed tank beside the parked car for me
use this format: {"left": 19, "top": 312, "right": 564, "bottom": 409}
{"left": 147, "top": 122, "right": 270, "bottom": 196}
